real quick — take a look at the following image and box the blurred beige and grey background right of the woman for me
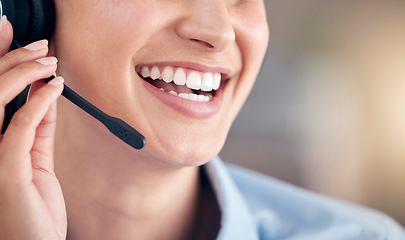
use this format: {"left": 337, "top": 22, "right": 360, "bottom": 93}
{"left": 220, "top": 0, "right": 405, "bottom": 226}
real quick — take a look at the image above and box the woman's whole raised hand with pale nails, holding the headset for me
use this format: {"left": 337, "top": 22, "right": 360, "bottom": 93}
{"left": 0, "top": 15, "right": 67, "bottom": 240}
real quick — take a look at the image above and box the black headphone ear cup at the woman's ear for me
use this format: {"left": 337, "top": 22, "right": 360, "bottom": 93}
{"left": 0, "top": 0, "right": 55, "bottom": 46}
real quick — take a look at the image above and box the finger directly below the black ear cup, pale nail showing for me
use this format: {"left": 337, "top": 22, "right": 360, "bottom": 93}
{"left": 0, "top": 40, "right": 48, "bottom": 75}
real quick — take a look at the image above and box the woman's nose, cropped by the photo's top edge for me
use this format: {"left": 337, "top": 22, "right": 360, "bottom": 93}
{"left": 176, "top": 0, "right": 235, "bottom": 52}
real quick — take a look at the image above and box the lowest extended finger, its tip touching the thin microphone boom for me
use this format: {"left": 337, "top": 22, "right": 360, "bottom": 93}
{"left": 0, "top": 77, "right": 63, "bottom": 169}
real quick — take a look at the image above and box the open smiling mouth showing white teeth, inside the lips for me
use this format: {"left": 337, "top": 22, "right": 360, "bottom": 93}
{"left": 135, "top": 66, "right": 221, "bottom": 102}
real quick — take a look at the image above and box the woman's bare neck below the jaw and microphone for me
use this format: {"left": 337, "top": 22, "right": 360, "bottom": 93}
{"left": 55, "top": 98, "right": 204, "bottom": 240}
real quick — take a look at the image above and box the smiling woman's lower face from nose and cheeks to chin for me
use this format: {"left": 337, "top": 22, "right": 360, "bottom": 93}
{"left": 54, "top": 0, "right": 268, "bottom": 165}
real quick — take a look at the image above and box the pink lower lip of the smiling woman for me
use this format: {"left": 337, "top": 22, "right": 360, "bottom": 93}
{"left": 142, "top": 80, "right": 224, "bottom": 118}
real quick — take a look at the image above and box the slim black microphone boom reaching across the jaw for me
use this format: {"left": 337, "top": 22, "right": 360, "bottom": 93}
{"left": 44, "top": 76, "right": 146, "bottom": 149}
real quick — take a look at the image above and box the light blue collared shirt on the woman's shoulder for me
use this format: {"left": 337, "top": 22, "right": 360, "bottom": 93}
{"left": 203, "top": 157, "right": 405, "bottom": 240}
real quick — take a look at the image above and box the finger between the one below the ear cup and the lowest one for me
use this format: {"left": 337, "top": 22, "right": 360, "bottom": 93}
{"left": 0, "top": 57, "right": 57, "bottom": 125}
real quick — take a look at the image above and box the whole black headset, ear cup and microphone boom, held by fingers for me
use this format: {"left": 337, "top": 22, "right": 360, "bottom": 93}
{"left": 0, "top": 0, "right": 146, "bottom": 149}
